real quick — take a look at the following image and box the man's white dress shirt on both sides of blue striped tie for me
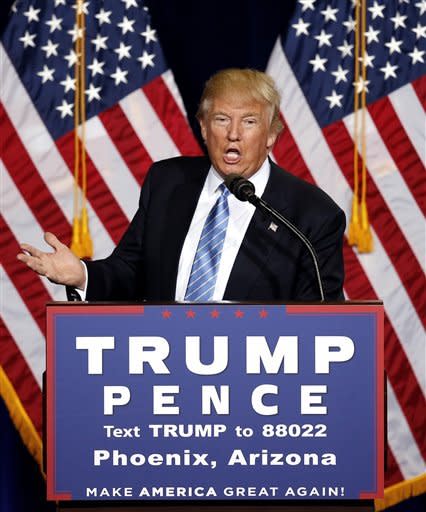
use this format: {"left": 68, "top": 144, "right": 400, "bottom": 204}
{"left": 175, "top": 159, "right": 270, "bottom": 301}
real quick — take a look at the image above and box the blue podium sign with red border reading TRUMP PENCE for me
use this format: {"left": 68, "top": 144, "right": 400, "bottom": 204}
{"left": 46, "top": 303, "right": 384, "bottom": 501}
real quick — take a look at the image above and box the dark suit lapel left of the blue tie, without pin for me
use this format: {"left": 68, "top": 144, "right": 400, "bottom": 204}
{"left": 161, "top": 159, "right": 210, "bottom": 298}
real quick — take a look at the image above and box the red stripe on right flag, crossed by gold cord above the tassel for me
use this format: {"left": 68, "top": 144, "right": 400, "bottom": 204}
{"left": 323, "top": 121, "right": 426, "bottom": 324}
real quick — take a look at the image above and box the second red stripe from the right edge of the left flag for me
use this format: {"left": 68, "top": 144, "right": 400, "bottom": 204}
{"left": 98, "top": 103, "right": 152, "bottom": 185}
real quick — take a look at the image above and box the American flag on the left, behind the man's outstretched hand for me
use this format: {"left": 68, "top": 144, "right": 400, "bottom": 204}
{"left": 0, "top": 0, "right": 201, "bottom": 470}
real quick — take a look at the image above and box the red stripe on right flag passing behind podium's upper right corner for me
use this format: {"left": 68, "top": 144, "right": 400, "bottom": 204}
{"left": 343, "top": 239, "right": 426, "bottom": 457}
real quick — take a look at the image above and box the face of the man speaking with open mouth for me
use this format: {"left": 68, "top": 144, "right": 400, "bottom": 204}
{"left": 200, "top": 94, "right": 276, "bottom": 178}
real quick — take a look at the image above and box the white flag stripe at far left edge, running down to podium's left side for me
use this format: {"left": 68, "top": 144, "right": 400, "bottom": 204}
{"left": 0, "top": 265, "right": 45, "bottom": 388}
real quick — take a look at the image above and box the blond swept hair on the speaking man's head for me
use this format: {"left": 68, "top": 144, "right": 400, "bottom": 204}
{"left": 196, "top": 68, "right": 283, "bottom": 135}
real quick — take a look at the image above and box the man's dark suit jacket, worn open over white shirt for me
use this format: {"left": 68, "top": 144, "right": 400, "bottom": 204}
{"left": 86, "top": 157, "right": 345, "bottom": 301}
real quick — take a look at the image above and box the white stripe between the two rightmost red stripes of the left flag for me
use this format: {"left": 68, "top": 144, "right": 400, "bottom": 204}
{"left": 119, "top": 89, "right": 180, "bottom": 162}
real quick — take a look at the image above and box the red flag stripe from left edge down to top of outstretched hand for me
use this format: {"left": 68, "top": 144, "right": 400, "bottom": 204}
{"left": 0, "top": 104, "right": 71, "bottom": 244}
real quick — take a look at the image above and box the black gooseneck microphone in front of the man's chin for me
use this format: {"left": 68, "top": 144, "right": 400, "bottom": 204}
{"left": 225, "top": 174, "right": 325, "bottom": 302}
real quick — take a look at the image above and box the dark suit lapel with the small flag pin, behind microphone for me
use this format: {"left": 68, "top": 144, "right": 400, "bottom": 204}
{"left": 223, "top": 162, "right": 286, "bottom": 300}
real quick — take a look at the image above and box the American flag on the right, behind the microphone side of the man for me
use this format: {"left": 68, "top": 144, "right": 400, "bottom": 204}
{"left": 267, "top": 0, "right": 426, "bottom": 504}
